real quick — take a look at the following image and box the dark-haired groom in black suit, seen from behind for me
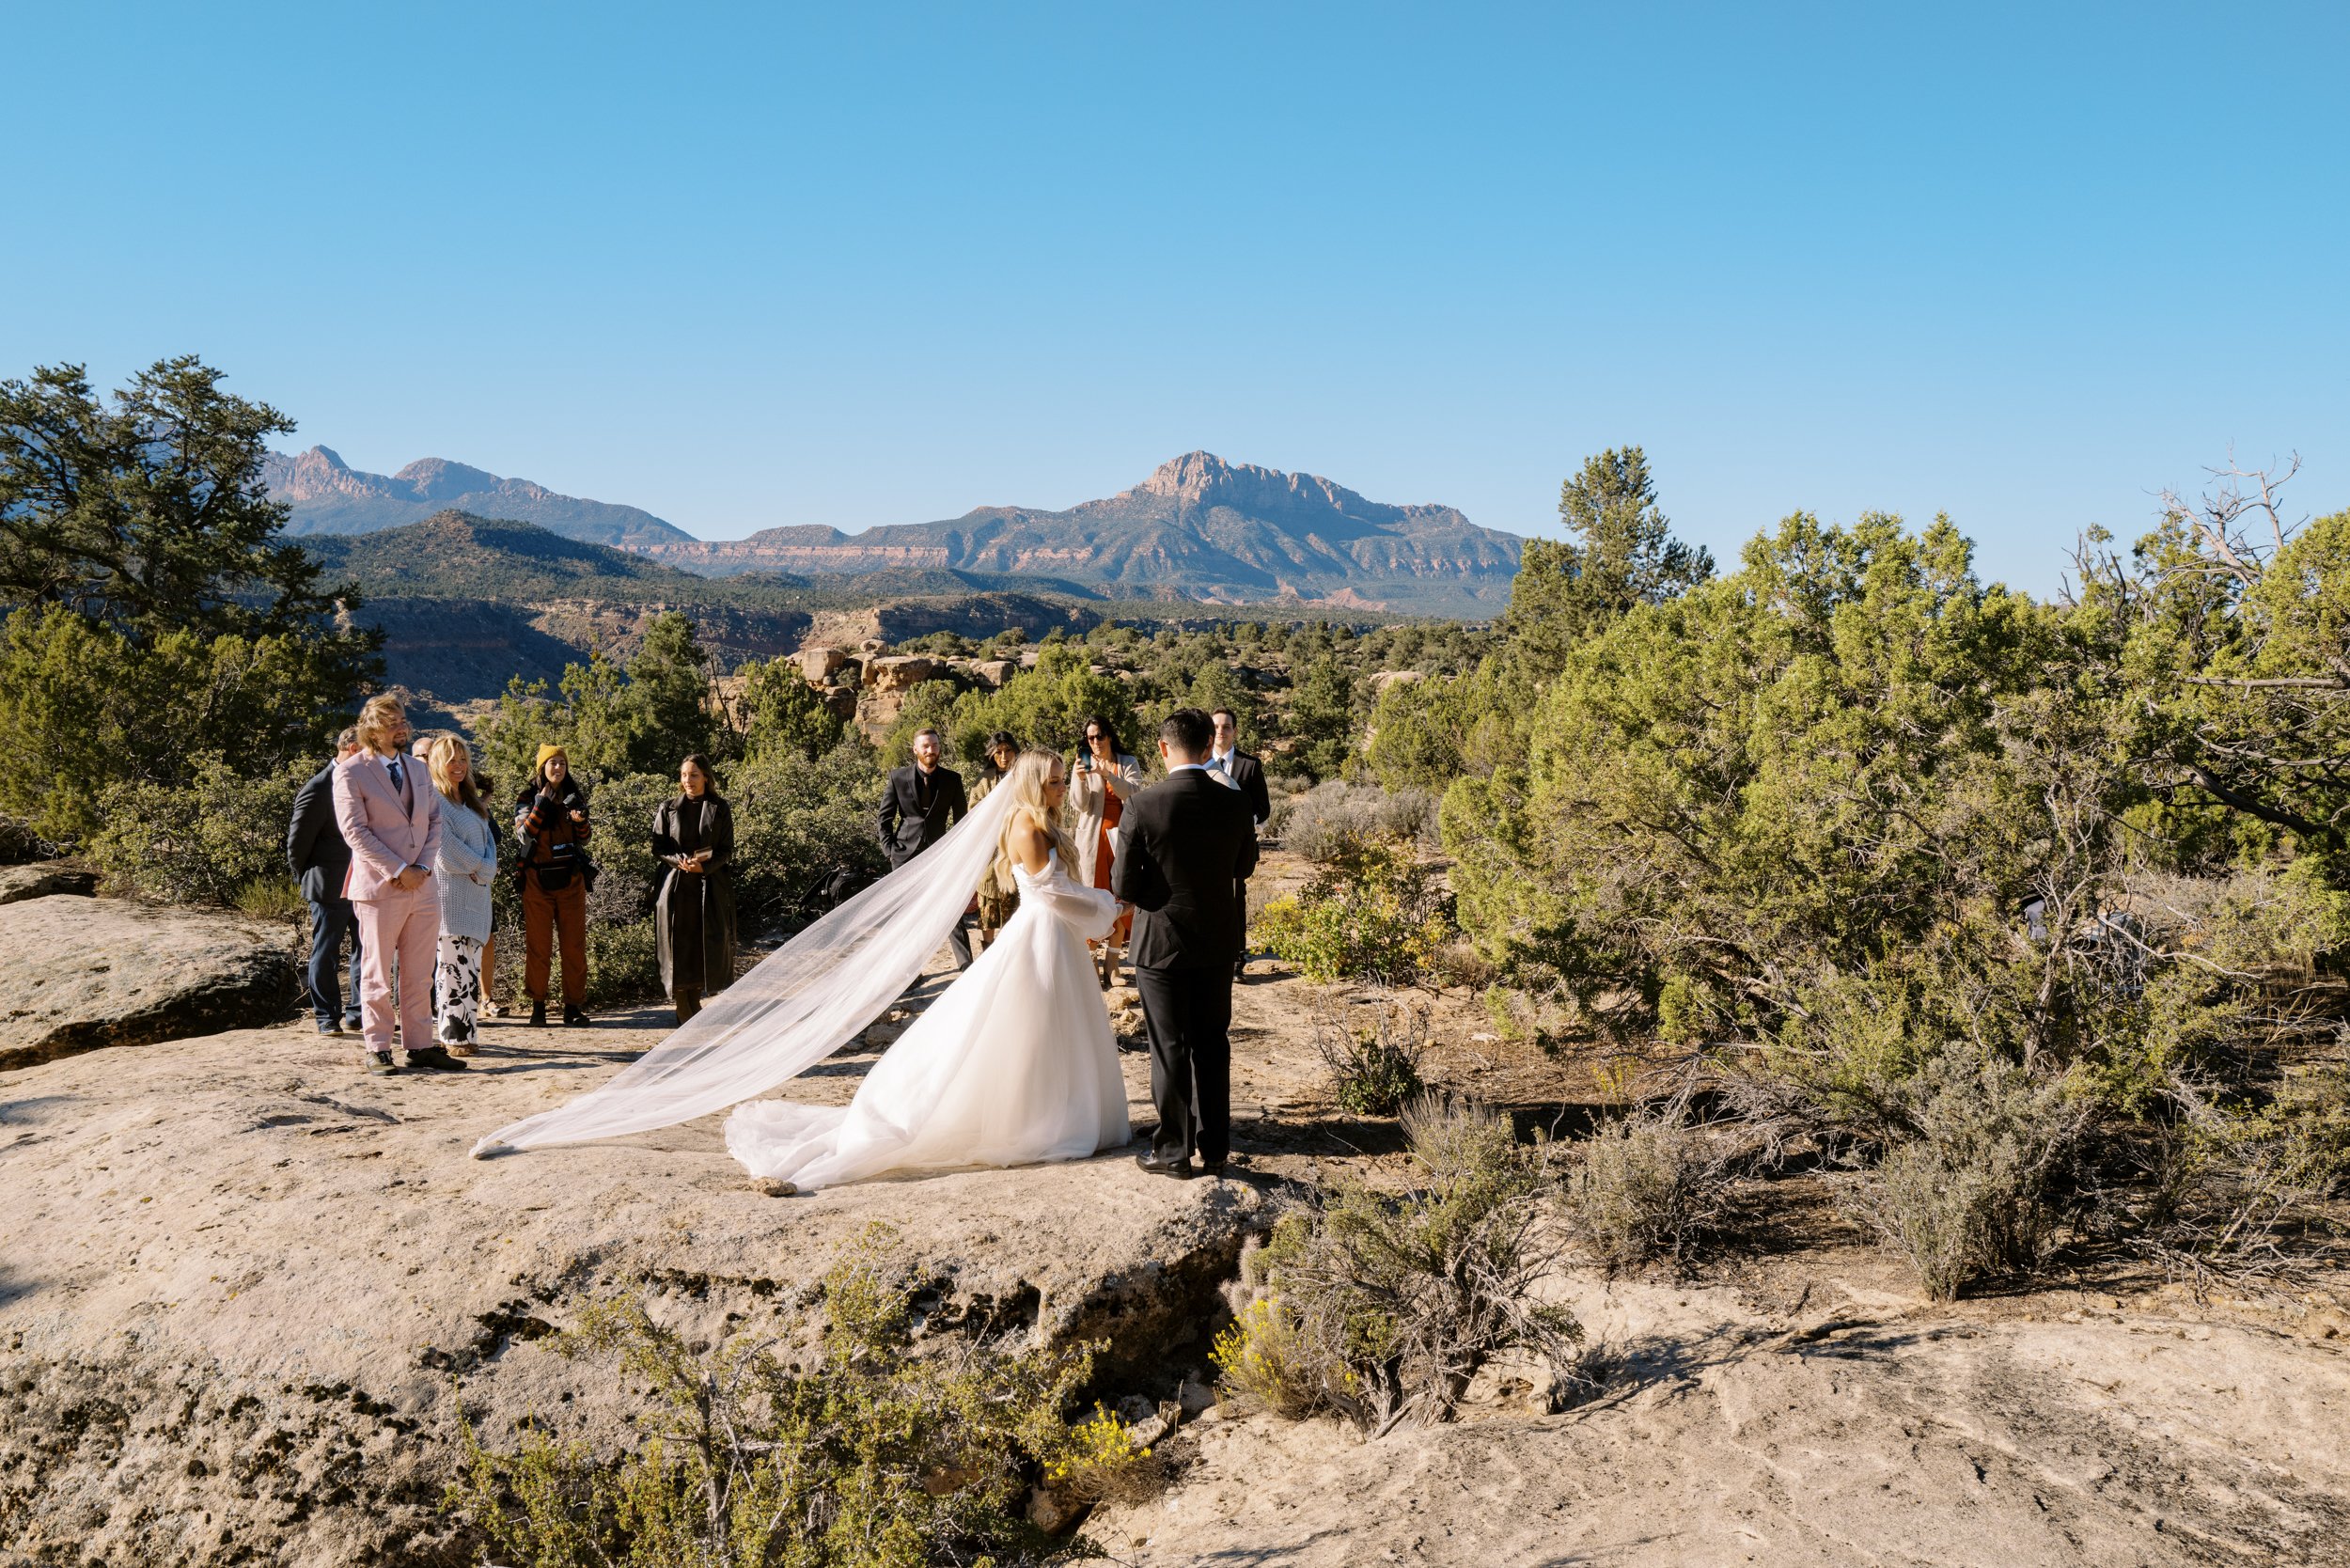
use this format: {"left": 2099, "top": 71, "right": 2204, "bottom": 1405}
{"left": 1109, "top": 708, "right": 1258, "bottom": 1175}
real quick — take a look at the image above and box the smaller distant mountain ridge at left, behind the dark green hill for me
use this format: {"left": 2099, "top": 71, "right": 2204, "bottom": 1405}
{"left": 261, "top": 447, "right": 694, "bottom": 550}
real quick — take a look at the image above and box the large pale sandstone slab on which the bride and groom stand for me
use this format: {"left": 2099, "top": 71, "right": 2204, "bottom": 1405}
{"left": 0, "top": 1009, "right": 1274, "bottom": 1568}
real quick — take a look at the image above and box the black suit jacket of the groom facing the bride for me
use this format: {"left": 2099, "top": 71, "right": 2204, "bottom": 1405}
{"left": 1109, "top": 769, "right": 1258, "bottom": 968}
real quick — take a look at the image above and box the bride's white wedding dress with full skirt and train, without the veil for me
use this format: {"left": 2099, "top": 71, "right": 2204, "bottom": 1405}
{"left": 727, "top": 854, "right": 1128, "bottom": 1192}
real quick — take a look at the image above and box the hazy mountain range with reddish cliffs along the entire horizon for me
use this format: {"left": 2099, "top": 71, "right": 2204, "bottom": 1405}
{"left": 268, "top": 447, "right": 1523, "bottom": 616}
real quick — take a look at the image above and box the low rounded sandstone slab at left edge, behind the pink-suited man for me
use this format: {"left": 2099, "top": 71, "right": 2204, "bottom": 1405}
{"left": 0, "top": 893, "right": 301, "bottom": 1070}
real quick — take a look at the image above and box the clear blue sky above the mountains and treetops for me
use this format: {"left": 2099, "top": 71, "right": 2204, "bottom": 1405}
{"left": 0, "top": 0, "right": 2350, "bottom": 590}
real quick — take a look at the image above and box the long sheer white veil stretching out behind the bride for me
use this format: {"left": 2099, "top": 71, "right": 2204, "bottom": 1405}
{"left": 473, "top": 790, "right": 1013, "bottom": 1159}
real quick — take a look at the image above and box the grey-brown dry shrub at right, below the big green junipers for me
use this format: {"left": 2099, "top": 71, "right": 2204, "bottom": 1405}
{"left": 1845, "top": 1043, "right": 2092, "bottom": 1300}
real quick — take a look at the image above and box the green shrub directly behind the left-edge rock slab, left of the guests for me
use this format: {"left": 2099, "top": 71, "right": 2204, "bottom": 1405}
{"left": 89, "top": 757, "right": 320, "bottom": 907}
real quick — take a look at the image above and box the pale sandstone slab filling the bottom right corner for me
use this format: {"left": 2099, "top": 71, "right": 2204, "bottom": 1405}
{"left": 1086, "top": 1286, "right": 2350, "bottom": 1568}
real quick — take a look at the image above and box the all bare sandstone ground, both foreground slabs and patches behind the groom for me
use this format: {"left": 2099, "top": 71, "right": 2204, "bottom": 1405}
{"left": 0, "top": 855, "right": 2350, "bottom": 1568}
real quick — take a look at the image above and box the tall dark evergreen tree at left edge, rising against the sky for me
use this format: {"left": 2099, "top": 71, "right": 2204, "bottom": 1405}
{"left": 0, "top": 357, "right": 379, "bottom": 844}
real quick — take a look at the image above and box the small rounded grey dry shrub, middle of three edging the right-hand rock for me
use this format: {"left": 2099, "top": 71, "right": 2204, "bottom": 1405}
{"left": 1565, "top": 1089, "right": 1730, "bottom": 1274}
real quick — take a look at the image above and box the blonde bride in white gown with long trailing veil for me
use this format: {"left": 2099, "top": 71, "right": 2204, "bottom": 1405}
{"left": 473, "top": 752, "right": 1128, "bottom": 1192}
